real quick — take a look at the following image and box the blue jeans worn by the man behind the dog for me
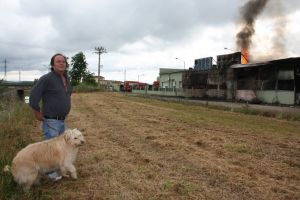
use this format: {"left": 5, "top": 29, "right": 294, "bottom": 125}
{"left": 43, "top": 118, "right": 66, "bottom": 140}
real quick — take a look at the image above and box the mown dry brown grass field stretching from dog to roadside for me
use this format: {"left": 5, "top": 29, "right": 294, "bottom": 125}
{"left": 2, "top": 92, "right": 300, "bottom": 200}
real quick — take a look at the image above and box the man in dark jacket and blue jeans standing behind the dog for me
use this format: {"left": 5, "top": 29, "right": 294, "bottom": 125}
{"left": 29, "top": 53, "right": 72, "bottom": 181}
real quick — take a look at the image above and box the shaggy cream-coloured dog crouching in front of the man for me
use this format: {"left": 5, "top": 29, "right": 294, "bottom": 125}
{"left": 11, "top": 129, "right": 85, "bottom": 190}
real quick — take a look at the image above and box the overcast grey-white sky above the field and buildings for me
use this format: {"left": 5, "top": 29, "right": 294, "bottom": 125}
{"left": 0, "top": 0, "right": 300, "bottom": 83}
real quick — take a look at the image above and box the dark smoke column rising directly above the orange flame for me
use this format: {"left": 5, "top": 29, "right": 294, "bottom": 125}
{"left": 236, "top": 0, "right": 269, "bottom": 61}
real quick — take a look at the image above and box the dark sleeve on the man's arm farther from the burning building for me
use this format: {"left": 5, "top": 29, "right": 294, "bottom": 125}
{"left": 29, "top": 76, "right": 47, "bottom": 111}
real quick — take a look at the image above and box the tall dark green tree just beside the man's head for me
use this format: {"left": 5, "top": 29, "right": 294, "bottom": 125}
{"left": 69, "top": 52, "right": 90, "bottom": 86}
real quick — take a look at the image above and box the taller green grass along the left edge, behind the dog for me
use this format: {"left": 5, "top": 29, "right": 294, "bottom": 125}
{"left": 0, "top": 101, "right": 40, "bottom": 199}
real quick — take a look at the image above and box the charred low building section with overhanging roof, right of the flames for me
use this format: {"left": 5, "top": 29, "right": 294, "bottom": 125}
{"left": 231, "top": 58, "right": 300, "bottom": 105}
